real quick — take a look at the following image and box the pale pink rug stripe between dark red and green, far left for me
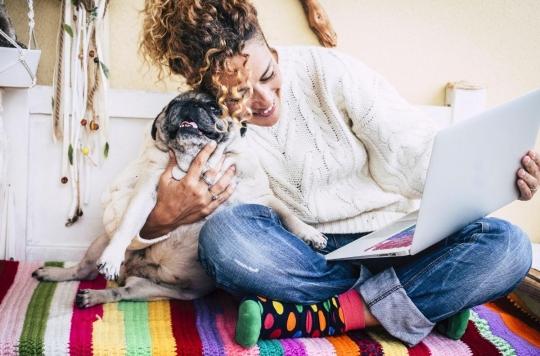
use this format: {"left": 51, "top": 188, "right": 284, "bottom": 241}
{"left": 0, "top": 262, "right": 42, "bottom": 355}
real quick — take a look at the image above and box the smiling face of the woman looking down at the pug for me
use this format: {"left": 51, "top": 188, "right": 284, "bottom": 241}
{"left": 221, "top": 39, "right": 281, "bottom": 126}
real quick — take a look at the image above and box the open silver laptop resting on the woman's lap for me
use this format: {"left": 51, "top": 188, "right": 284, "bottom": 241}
{"left": 326, "top": 89, "right": 540, "bottom": 260}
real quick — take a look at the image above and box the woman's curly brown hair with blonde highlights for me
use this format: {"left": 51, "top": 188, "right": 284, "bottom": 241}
{"left": 140, "top": 0, "right": 267, "bottom": 121}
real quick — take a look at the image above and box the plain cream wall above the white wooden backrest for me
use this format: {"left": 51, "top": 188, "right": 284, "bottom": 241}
{"left": 6, "top": 0, "right": 540, "bottom": 106}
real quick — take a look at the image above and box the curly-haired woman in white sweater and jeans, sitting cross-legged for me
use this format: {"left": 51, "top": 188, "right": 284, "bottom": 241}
{"left": 136, "top": 0, "right": 540, "bottom": 346}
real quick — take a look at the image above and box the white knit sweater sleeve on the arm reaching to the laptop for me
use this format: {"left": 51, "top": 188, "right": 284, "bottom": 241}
{"left": 326, "top": 52, "right": 438, "bottom": 199}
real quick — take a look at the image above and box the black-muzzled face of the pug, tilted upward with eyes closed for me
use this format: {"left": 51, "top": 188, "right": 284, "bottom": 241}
{"left": 152, "top": 91, "right": 234, "bottom": 170}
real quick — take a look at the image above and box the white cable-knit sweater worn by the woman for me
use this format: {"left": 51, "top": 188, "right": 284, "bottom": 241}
{"left": 246, "top": 47, "right": 437, "bottom": 233}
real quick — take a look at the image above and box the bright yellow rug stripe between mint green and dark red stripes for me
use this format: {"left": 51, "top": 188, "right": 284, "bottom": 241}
{"left": 148, "top": 300, "right": 176, "bottom": 356}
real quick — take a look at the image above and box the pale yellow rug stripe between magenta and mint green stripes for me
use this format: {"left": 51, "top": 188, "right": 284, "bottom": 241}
{"left": 92, "top": 281, "right": 126, "bottom": 356}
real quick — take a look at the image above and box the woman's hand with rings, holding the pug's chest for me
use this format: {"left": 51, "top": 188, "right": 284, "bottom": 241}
{"left": 140, "top": 142, "right": 235, "bottom": 239}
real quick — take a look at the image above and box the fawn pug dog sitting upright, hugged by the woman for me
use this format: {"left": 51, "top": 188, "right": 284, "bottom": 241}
{"left": 33, "top": 91, "right": 326, "bottom": 308}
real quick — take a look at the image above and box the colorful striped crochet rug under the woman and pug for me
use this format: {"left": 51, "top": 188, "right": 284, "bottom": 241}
{"left": 0, "top": 261, "right": 540, "bottom": 356}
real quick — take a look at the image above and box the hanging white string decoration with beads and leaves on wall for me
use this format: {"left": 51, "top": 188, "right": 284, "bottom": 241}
{"left": 52, "top": 0, "right": 109, "bottom": 226}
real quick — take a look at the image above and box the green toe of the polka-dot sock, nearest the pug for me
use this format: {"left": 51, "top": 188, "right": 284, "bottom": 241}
{"left": 235, "top": 300, "right": 262, "bottom": 347}
